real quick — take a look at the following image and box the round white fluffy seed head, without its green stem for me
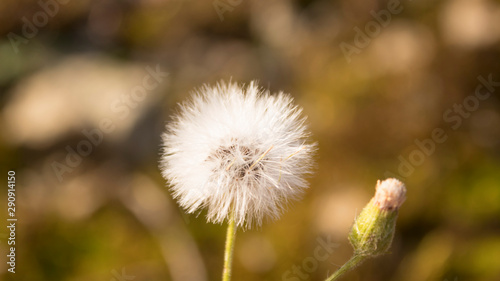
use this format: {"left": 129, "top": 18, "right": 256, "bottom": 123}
{"left": 161, "top": 82, "right": 315, "bottom": 228}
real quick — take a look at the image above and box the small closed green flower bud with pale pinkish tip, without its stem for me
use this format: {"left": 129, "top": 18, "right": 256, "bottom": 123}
{"left": 349, "top": 178, "right": 406, "bottom": 256}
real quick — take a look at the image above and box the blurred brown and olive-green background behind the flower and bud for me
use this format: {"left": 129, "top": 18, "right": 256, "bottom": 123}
{"left": 0, "top": 0, "right": 500, "bottom": 281}
